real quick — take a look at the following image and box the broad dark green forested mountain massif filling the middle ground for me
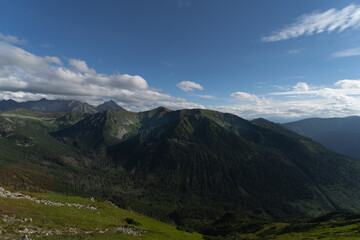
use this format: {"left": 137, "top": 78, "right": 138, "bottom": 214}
{"left": 0, "top": 107, "right": 360, "bottom": 231}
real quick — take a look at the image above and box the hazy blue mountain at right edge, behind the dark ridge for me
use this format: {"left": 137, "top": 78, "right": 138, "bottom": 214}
{"left": 282, "top": 116, "right": 360, "bottom": 159}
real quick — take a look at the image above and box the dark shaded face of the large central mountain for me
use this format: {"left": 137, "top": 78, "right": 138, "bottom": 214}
{"left": 57, "top": 108, "right": 360, "bottom": 225}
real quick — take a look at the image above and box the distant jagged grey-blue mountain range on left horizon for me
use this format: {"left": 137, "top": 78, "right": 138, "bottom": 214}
{"left": 0, "top": 98, "right": 125, "bottom": 113}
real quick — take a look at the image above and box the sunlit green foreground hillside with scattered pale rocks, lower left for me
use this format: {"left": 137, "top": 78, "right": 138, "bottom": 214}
{"left": 0, "top": 188, "right": 202, "bottom": 240}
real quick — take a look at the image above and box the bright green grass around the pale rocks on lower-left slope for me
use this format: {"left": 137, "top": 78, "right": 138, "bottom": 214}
{"left": 0, "top": 188, "right": 202, "bottom": 240}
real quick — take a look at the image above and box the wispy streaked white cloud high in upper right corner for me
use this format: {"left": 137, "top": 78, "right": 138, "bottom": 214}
{"left": 262, "top": 4, "right": 360, "bottom": 42}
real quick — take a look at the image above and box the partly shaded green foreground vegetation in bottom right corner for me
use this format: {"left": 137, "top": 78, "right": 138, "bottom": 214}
{"left": 201, "top": 213, "right": 360, "bottom": 240}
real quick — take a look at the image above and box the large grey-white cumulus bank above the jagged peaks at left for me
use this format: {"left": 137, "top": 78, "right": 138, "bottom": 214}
{"left": 0, "top": 42, "right": 203, "bottom": 111}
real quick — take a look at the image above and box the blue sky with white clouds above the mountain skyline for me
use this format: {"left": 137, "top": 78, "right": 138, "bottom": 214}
{"left": 0, "top": 0, "right": 360, "bottom": 122}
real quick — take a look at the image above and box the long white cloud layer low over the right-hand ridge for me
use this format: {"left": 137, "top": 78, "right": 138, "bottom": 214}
{"left": 217, "top": 79, "right": 360, "bottom": 122}
